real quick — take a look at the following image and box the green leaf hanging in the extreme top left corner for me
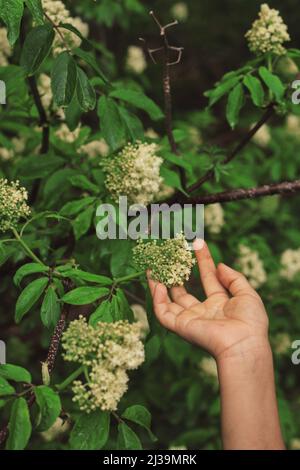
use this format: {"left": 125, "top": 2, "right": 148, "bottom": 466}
{"left": 0, "top": 0, "right": 24, "bottom": 46}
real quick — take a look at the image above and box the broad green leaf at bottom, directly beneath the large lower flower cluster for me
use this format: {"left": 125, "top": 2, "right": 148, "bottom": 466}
{"left": 70, "top": 411, "right": 110, "bottom": 450}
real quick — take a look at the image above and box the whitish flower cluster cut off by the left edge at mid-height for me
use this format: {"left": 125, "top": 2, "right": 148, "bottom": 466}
{"left": 0, "top": 178, "right": 30, "bottom": 232}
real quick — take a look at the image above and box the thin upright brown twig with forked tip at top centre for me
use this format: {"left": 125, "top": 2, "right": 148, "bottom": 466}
{"left": 141, "top": 11, "right": 186, "bottom": 189}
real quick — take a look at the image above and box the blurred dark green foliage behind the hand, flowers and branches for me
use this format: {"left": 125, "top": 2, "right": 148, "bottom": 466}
{"left": 0, "top": 0, "right": 300, "bottom": 449}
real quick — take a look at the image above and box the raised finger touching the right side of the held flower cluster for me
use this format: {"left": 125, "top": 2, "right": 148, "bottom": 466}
{"left": 194, "top": 240, "right": 227, "bottom": 297}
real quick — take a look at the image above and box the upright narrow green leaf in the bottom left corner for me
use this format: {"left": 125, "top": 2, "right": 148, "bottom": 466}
{"left": 6, "top": 397, "right": 32, "bottom": 450}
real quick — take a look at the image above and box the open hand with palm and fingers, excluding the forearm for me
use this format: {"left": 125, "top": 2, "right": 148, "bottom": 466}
{"left": 148, "top": 241, "right": 268, "bottom": 360}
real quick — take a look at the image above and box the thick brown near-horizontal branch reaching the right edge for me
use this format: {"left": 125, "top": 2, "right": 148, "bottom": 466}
{"left": 184, "top": 180, "right": 300, "bottom": 204}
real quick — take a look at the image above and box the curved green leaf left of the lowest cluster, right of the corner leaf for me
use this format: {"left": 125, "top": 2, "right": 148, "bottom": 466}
{"left": 34, "top": 385, "right": 61, "bottom": 432}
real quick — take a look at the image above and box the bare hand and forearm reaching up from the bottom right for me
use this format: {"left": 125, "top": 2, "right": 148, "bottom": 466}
{"left": 148, "top": 241, "right": 285, "bottom": 450}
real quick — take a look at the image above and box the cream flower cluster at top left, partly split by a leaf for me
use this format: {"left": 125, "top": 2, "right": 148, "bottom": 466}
{"left": 42, "top": 0, "right": 89, "bottom": 55}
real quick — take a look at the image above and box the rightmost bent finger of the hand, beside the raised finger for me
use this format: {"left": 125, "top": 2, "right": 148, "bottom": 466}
{"left": 217, "top": 263, "right": 259, "bottom": 297}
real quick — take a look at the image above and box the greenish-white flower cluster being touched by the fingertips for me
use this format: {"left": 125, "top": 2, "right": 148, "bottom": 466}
{"left": 133, "top": 234, "right": 195, "bottom": 287}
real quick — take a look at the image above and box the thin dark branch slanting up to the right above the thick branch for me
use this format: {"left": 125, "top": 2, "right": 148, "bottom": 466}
{"left": 187, "top": 104, "right": 274, "bottom": 193}
